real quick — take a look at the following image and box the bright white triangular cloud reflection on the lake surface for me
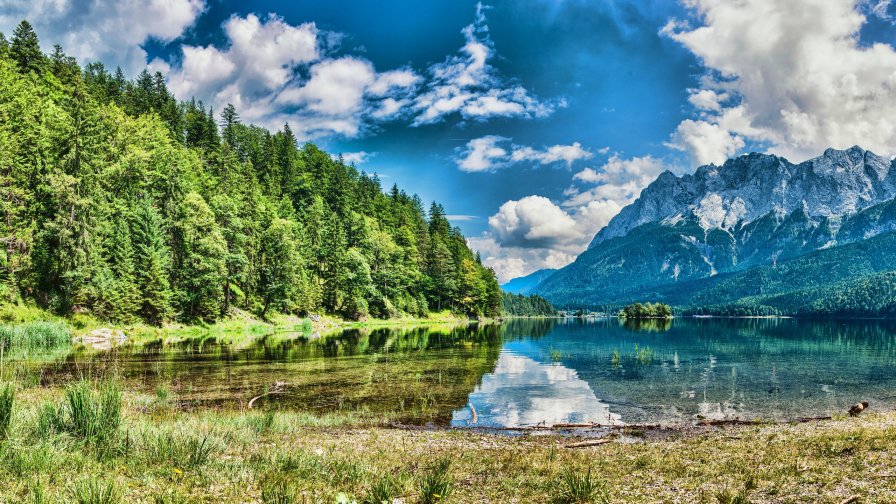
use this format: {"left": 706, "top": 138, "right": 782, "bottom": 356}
{"left": 451, "top": 343, "right": 621, "bottom": 427}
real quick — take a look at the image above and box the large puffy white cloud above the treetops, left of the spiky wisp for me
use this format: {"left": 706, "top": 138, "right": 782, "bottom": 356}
{"left": 153, "top": 14, "right": 420, "bottom": 139}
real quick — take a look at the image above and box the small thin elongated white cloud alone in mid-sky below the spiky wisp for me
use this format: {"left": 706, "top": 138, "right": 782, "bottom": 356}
{"left": 455, "top": 135, "right": 593, "bottom": 172}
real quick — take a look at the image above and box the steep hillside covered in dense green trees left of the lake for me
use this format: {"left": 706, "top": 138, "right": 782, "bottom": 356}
{"left": 0, "top": 22, "right": 502, "bottom": 323}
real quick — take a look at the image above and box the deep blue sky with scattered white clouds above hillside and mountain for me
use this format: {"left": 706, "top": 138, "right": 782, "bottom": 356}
{"left": 0, "top": 0, "right": 896, "bottom": 282}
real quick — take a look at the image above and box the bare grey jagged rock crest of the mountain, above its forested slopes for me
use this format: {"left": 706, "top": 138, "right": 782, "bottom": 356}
{"left": 589, "top": 146, "right": 896, "bottom": 248}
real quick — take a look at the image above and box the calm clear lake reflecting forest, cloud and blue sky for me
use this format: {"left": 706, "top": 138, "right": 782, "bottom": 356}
{"left": 33, "top": 319, "right": 896, "bottom": 427}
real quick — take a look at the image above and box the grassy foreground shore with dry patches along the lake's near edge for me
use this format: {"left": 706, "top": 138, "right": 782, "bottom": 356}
{"left": 0, "top": 382, "right": 896, "bottom": 504}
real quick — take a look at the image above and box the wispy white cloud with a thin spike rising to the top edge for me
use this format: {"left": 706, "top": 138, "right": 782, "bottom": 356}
{"left": 413, "top": 3, "right": 566, "bottom": 125}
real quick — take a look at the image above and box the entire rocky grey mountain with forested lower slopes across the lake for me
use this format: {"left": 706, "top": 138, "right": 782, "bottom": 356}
{"left": 533, "top": 147, "right": 896, "bottom": 315}
